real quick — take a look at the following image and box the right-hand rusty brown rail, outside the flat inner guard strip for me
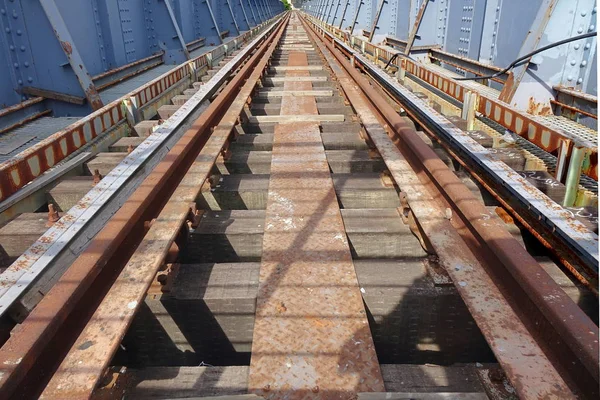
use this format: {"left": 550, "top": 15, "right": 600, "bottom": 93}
{"left": 304, "top": 14, "right": 598, "bottom": 398}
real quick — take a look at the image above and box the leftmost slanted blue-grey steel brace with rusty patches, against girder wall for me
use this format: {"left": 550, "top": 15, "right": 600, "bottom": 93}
{"left": 38, "top": 0, "right": 104, "bottom": 110}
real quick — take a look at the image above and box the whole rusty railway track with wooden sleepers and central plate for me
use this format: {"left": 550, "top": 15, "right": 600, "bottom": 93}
{"left": 0, "top": 12, "right": 598, "bottom": 399}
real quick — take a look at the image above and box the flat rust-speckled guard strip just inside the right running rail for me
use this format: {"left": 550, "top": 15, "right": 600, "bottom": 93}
{"left": 302, "top": 17, "right": 573, "bottom": 399}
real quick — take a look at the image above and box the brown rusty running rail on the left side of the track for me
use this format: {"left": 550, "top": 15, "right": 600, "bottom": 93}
{"left": 0, "top": 17, "right": 286, "bottom": 398}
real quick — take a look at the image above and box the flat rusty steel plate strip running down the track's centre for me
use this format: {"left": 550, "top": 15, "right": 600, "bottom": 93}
{"left": 249, "top": 18, "right": 384, "bottom": 399}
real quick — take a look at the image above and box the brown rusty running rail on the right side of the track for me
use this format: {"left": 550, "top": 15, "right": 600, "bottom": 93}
{"left": 302, "top": 13, "right": 598, "bottom": 398}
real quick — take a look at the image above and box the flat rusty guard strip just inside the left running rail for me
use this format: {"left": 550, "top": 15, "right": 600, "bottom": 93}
{"left": 37, "top": 14, "right": 285, "bottom": 399}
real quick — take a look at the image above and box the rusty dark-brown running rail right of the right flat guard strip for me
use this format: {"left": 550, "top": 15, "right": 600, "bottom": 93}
{"left": 304, "top": 14, "right": 598, "bottom": 398}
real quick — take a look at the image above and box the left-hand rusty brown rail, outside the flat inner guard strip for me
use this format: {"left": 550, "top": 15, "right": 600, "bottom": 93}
{"left": 0, "top": 14, "right": 288, "bottom": 398}
